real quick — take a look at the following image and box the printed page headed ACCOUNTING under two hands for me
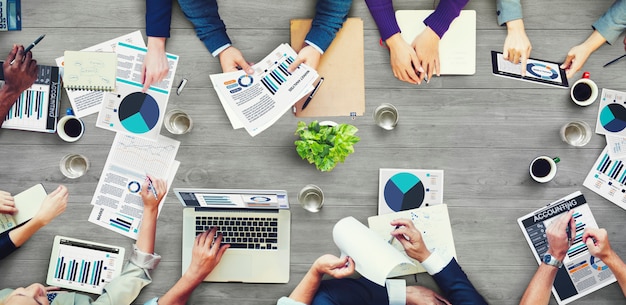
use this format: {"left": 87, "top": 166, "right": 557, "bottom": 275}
{"left": 517, "top": 192, "right": 616, "bottom": 305}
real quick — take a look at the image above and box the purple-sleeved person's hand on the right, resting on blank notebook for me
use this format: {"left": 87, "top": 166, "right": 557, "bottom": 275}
{"left": 411, "top": 27, "right": 441, "bottom": 82}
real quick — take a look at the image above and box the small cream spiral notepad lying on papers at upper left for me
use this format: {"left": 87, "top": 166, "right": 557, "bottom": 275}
{"left": 63, "top": 51, "right": 117, "bottom": 91}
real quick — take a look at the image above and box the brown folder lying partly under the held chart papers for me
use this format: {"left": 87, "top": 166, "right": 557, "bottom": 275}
{"left": 291, "top": 18, "right": 365, "bottom": 117}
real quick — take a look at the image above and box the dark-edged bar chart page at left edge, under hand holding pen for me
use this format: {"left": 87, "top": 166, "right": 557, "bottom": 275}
{"left": 0, "top": 61, "right": 61, "bottom": 133}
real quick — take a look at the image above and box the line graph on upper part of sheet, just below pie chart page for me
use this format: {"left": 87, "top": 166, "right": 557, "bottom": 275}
{"left": 109, "top": 133, "right": 180, "bottom": 178}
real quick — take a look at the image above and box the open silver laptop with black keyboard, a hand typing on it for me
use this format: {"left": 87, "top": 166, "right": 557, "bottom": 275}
{"left": 174, "top": 188, "right": 291, "bottom": 283}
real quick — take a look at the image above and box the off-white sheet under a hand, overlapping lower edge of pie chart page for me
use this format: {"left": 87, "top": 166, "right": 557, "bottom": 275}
{"left": 367, "top": 204, "right": 456, "bottom": 277}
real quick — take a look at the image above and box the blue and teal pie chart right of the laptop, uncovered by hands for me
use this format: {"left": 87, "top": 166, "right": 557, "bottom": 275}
{"left": 384, "top": 172, "right": 425, "bottom": 212}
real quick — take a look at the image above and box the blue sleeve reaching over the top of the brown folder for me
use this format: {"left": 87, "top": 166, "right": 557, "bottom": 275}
{"left": 305, "top": 0, "right": 352, "bottom": 52}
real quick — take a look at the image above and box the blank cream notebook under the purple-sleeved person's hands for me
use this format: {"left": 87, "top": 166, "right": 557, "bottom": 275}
{"left": 396, "top": 10, "right": 476, "bottom": 75}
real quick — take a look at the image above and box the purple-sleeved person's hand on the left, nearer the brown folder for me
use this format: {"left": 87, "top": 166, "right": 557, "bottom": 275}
{"left": 385, "top": 33, "right": 424, "bottom": 85}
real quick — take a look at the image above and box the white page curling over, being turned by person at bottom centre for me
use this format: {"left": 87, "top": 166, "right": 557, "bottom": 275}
{"left": 333, "top": 217, "right": 413, "bottom": 286}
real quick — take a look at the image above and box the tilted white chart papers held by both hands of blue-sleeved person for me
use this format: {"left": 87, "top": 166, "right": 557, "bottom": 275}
{"left": 211, "top": 44, "right": 319, "bottom": 136}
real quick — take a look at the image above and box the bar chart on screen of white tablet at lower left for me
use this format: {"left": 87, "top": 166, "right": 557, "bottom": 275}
{"left": 51, "top": 239, "right": 120, "bottom": 289}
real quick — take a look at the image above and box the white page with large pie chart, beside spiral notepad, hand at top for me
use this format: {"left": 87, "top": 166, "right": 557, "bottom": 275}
{"left": 96, "top": 42, "right": 178, "bottom": 141}
